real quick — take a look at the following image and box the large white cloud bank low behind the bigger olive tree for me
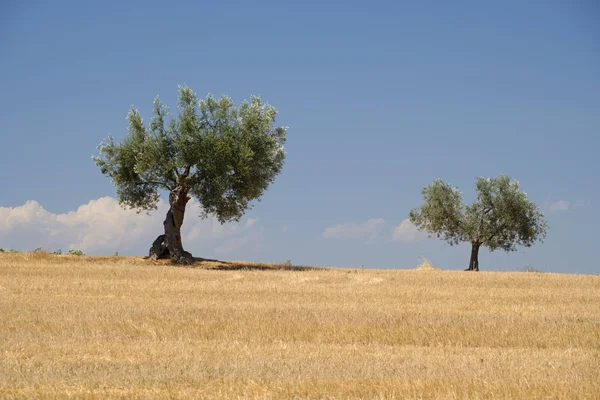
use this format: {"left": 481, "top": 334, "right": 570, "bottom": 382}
{"left": 0, "top": 197, "right": 257, "bottom": 255}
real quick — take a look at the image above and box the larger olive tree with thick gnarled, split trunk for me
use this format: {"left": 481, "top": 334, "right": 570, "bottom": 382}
{"left": 92, "top": 87, "right": 287, "bottom": 264}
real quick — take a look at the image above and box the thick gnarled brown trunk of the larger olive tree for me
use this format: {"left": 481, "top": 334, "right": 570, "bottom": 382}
{"left": 150, "top": 186, "right": 194, "bottom": 264}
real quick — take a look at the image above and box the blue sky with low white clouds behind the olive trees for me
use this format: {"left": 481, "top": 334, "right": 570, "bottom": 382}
{"left": 0, "top": 0, "right": 600, "bottom": 273}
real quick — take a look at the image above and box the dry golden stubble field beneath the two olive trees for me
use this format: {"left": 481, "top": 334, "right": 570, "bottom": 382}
{"left": 0, "top": 254, "right": 600, "bottom": 399}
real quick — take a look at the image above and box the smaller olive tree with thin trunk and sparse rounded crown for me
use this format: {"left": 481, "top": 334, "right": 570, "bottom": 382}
{"left": 409, "top": 175, "right": 548, "bottom": 271}
